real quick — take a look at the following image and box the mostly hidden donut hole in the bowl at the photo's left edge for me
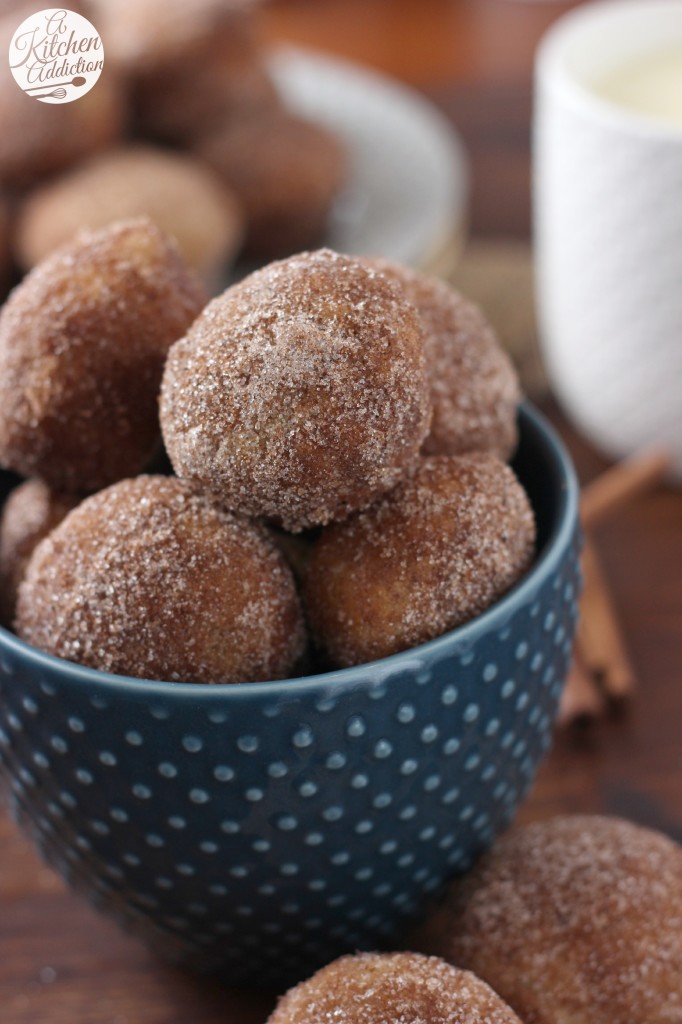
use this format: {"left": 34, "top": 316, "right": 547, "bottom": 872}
{"left": 0, "top": 479, "right": 81, "bottom": 628}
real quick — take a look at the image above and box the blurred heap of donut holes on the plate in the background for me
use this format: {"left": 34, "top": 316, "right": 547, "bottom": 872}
{"left": 0, "top": 0, "right": 346, "bottom": 287}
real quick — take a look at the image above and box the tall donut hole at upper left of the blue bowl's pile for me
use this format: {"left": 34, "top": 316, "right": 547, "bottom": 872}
{"left": 0, "top": 218, "right": 206, "bottom": 494}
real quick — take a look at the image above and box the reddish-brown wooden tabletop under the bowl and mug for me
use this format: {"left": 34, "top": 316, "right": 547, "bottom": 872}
{"left": 0, "top": 0, "right": 682, "bottom": 1024}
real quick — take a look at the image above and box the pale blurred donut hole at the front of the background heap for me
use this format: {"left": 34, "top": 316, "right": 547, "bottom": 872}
{"left": 15, "top": 145, "right": 244, "bottom": 284}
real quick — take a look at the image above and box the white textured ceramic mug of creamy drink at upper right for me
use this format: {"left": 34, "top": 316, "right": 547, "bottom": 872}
{"left": 534, "top": 0, "right": 682, "bottom": 479}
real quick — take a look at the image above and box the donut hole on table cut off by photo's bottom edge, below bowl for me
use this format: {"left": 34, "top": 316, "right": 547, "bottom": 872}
{"left": 267, "top": 953, "right": 521, "bottom": 1024}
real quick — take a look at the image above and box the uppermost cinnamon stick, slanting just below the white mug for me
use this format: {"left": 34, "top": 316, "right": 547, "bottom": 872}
{"left": 581, "top": 449, "right": 671, "bottom": 528}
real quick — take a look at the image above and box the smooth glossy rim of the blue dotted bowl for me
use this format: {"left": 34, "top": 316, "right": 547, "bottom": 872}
{"left": 0, "top": 400, "right": 580, "bottom": 703}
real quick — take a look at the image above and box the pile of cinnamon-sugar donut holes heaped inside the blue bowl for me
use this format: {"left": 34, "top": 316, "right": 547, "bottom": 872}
{"left": 0, "top": 218, "right": 535, "bottom": 683}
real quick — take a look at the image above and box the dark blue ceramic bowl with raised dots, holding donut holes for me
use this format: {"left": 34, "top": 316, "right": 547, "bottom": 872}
{"left": 0, "top": 407, "right": 580, "bottom": 988}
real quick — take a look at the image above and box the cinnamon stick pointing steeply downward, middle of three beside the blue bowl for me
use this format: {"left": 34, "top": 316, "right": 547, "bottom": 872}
{"left": 578, "top": 537, "right": 635, "bottom": 700}
